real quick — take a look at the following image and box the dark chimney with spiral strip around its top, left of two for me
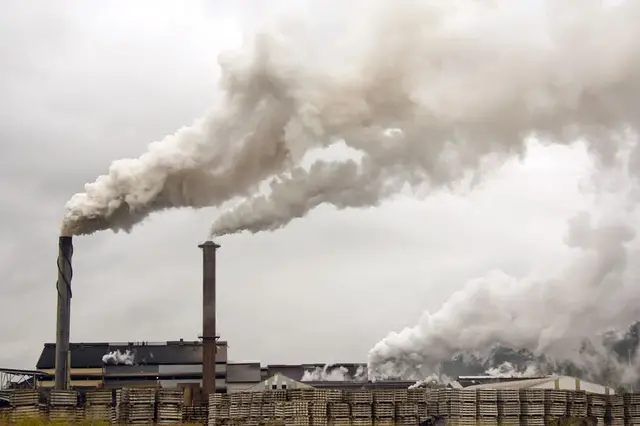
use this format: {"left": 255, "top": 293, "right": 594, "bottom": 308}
{"left": 55, "top": 237, "right": 73, "bottom": 389}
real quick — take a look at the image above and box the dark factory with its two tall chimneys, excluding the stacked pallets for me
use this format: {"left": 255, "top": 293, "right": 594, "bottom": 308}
{"left": 31, "top": 236, "right": 414, "bottom": 394}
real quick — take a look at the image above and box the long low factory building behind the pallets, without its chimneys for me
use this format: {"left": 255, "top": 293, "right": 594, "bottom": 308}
{"left": 36, "top": 340, "right": 414, "bottom": 393}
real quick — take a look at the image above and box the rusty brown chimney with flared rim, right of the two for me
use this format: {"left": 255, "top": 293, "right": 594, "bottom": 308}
{"left": 198, "top": 241, "right": 220, "bottom": 398}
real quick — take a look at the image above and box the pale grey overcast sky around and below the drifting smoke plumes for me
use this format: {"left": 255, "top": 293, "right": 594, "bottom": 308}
{"left": 0, "top": 0, "right": 589, "bottom": 368}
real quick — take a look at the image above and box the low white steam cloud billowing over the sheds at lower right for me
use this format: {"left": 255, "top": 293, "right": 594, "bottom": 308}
{"left": 369, "top": 158, "right": 640, "bottom": 382}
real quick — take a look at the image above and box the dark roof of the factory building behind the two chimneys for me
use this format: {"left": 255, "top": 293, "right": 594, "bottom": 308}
{"left": 36, "top": 341, "right": 227, "bottom": 370}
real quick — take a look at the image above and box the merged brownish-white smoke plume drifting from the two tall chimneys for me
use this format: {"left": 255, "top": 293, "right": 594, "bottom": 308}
{"left": 62, "top": 0, "right": 640, "bottom": 235}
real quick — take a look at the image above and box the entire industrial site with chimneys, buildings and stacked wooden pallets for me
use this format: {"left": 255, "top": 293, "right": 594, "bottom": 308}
{"left": 0, "top": 237, "right": 640, "bottom": 426}
